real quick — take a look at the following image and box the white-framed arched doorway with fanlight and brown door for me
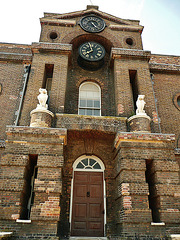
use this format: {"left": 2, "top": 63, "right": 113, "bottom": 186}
{"left": 70, "top": 155, "right": 106, "bottom": 237}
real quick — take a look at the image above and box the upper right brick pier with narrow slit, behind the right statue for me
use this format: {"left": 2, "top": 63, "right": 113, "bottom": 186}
{"left": 111, "top": 48, "right": 159, "bottom": 132}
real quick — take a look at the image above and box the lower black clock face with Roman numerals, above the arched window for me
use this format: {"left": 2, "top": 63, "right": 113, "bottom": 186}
{"left": 79, "top": 42, "right": 105, "bottom": 62}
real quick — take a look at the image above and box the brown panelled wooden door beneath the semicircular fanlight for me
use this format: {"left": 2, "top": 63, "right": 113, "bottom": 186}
{"left": 71, "top": 171, "right": 104, "bottom": 237}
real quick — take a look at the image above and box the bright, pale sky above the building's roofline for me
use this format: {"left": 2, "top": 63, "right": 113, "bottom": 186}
{"left": 0, "top": 0, "right": 180, "bottom": 56}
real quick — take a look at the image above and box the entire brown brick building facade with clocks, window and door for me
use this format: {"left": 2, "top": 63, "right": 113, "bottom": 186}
{"left": 0, "top": 6, "right": 180, "bottom": 239}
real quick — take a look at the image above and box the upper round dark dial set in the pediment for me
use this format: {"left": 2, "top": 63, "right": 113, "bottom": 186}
{"left": 80, "top": 16, "right": 106, "bottom": 33}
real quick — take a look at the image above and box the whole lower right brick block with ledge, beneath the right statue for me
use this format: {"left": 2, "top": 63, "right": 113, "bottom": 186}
{"left": 115, "top": 133, "right": 179, "bottom": 237}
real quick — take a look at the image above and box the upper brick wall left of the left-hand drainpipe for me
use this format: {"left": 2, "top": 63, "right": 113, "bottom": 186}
{"left": 0, "top": 44, "right": 31, "bottom": 139}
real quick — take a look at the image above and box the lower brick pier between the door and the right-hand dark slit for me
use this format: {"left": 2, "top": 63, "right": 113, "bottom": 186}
{"left": 115, "top": 142, "right": 151, "bottom": 237}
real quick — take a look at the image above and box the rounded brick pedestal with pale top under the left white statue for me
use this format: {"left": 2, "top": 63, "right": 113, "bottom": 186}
{"left": 30, "top": 109, "right": 54, "bottom": 128}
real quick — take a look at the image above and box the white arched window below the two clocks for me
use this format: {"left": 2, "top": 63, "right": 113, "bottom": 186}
{"left": 78, "top": 82, "right": 101, "bottom": 116}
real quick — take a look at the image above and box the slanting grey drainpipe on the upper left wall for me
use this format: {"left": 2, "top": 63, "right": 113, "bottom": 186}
{"left": 14, "top": 64, "right": 31, "bottom": 126}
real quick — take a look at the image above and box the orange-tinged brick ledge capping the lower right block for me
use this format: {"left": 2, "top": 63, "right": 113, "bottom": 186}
{"left": 114, "top": 132, "right": 175, "bottom": 148}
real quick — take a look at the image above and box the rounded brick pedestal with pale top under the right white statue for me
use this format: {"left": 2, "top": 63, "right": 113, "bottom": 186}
{"left": 128, "top": 114, "right": 151, "bottom": 132}
